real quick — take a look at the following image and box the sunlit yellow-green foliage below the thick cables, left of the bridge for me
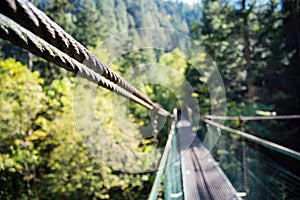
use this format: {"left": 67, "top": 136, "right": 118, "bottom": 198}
{"left": 0, "top": 59, "right": 159, "bottom": 199}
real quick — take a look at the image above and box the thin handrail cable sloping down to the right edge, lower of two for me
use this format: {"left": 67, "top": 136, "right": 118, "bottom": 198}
{"left": 204, "top": 119, "right": 300, "bottom": 160}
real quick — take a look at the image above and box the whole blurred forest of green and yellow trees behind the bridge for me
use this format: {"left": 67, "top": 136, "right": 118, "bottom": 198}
{"left": 0, "top": 0, "right": 300, "bottom": 200}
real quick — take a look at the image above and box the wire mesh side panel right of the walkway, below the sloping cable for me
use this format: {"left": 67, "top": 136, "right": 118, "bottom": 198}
{"left": 211, "top": 124, "right": 300, "bottom": 199}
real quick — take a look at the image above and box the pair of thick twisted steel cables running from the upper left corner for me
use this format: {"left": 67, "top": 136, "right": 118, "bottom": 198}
{"left": 0, "top": 0, "right": 172, "bottom": 117}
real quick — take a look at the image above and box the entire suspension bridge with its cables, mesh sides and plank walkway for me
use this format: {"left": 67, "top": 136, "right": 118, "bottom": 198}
{"left": 0, "top": 0, "right": 300, "bottom": 200}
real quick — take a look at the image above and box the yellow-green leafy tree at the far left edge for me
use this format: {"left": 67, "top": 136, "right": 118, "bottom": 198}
{"left": 0, "top": 59, "right": 45, "bottom": 199}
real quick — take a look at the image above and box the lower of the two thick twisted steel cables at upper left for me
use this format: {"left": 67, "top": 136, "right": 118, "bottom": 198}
{"left": 0, "top": 14, "right": 153, "bottom": 109}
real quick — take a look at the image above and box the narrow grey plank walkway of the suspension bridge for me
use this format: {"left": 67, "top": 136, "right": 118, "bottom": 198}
{"left": 177, "top": 119, "right": 240, "bottom": 200}
